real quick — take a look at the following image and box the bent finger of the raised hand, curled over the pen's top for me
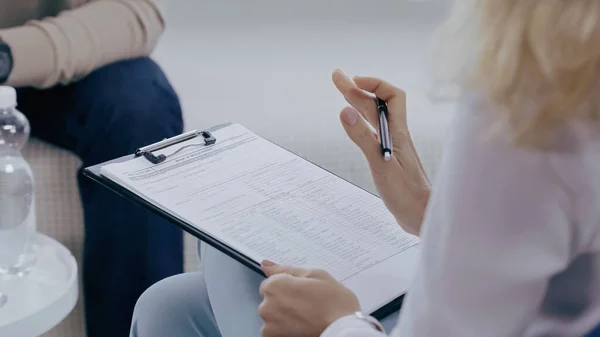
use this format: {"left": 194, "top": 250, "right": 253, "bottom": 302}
{"left": 354, "top": 76, "right": 407, "bottom": 132}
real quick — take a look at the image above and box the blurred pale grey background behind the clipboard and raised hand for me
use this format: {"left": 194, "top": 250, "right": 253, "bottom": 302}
{"left": 155, "top": 0, "right": 451, "bottom": 190}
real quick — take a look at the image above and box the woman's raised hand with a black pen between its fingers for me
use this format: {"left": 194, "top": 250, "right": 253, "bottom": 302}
{"left": 333, "top": 70, "right": 431, "bottom": 235}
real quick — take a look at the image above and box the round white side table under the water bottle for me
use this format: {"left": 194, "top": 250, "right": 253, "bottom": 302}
{"left": 0, "top": 234, "right": 79, "bottom": 337}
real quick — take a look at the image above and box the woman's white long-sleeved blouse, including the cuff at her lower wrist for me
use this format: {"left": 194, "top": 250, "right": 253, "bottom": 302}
{"left": 322, "top": 97, "right": 600, "bottom": 337}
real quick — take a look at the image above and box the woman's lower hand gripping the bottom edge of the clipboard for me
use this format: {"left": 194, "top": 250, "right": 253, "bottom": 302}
{"left": 258, "top": 261, "right": 360, "bottom": 337}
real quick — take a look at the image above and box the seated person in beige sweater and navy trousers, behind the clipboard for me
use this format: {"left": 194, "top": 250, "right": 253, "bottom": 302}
{"left": 0, "top": 0, "right": 183, "bottom": 337}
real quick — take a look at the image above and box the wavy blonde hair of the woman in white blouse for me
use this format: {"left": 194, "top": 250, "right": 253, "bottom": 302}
{"left": 438, "top": 0, "right": 600, "bottom": 146}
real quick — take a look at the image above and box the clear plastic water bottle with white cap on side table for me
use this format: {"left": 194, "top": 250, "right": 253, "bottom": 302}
{"left": 0, "top": 86, "right": 36, "bottom": 276}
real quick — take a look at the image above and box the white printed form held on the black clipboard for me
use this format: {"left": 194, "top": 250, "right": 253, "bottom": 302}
{"left": 100, "top": 124, "right": 419, "bottom": 313}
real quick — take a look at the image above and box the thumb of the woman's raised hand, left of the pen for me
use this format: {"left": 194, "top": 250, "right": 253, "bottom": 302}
{"left": 340, "top": 107, "right": 381, "bottom": 164}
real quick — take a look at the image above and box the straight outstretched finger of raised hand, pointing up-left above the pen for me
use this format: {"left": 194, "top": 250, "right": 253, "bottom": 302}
{"left": 332, "top": 69, "right": 378, "bottom": 125}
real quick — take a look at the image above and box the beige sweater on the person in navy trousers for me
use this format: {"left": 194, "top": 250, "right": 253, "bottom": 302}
{"left": 0, "top": 0, "right": 164, "bottom": 88}
